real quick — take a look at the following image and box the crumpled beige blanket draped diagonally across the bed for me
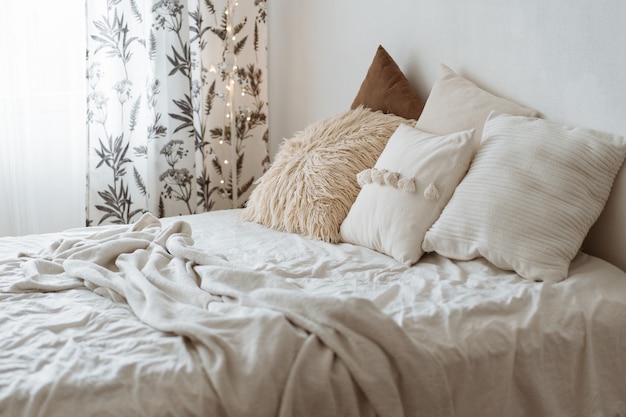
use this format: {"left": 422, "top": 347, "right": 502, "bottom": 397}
{"left": 11, "top": 214, "right": 453, "bottom": 417}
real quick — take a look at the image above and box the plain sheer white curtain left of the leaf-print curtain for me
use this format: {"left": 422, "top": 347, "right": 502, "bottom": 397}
{"left": 0, "top": 0, "right": 86, "bottom": 236}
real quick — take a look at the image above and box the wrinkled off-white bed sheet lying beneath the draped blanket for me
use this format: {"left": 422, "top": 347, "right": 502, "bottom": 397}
{"left": 0, "top": 211, "right": 626, "bottom": 416}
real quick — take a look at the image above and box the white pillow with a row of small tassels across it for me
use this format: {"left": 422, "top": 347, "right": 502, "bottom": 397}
{"left": 341, "top": 124, "right": 474, "bottom": 265}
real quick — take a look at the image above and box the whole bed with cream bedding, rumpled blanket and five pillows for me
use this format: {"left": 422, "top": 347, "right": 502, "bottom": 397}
{"left": 0, "top": 47, "right": 626, "bottom": 416}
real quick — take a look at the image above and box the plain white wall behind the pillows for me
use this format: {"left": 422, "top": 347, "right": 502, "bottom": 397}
{"left": 268, "top": 0, "right": 626, "bottom": 268}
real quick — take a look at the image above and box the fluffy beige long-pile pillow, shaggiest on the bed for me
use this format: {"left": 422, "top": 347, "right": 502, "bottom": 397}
{"left": 242, "top": 107, "right": 415, "bottom": 243}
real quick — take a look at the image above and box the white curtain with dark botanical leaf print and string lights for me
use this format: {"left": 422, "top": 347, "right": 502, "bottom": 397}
{"left": 87, "top": 0, "right": 269, "bottom": 225}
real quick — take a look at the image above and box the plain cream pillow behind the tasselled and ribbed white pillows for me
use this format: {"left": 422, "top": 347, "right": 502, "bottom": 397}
{"left": 415, "top": 64, "right": 538, "bottom": 142}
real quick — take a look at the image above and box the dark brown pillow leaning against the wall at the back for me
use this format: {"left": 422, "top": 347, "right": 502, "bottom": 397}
{"left": 351, "top": 45, "right": 424, "bottom": 119}
